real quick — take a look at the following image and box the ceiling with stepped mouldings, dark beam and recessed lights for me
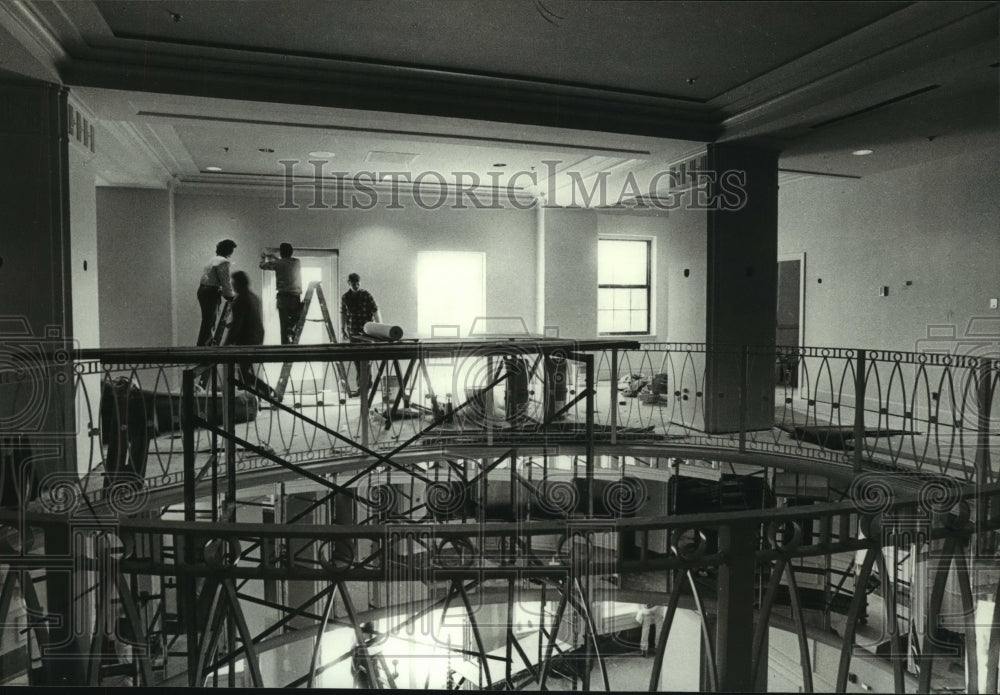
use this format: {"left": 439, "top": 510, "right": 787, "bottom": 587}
{"left": 0, "top": 0, "right": 1000, "bottom": 192}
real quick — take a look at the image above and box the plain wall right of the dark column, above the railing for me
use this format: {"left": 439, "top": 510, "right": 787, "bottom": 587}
{"left": 778, "top": 148, "right": 1000, "bottom": 350}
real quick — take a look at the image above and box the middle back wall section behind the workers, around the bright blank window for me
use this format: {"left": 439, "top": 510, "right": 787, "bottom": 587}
{"left": 174, "top": 186, "right": 535, "bottom": 344}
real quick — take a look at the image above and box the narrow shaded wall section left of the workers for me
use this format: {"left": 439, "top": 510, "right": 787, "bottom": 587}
{"left": 97, "top": 186, "right": 176, "bottom": 347}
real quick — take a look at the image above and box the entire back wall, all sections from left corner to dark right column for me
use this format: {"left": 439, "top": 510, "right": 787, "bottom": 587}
{"left": 97, "top": 185, "right": 705, "bottom": 347}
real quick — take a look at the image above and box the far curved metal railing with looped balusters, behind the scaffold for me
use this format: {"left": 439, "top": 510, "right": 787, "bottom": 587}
{"left": 48, "top": 343, "right": 1000, "bottom": 500}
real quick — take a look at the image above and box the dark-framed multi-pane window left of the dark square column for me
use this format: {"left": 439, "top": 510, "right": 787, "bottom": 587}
{"left": 597, "top": 239, "right": 652, "bottom": 335}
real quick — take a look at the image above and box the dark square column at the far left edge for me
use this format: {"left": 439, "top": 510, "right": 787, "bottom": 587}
{"left": 0, "top": 79, "right": 76, "bottom": 478}
